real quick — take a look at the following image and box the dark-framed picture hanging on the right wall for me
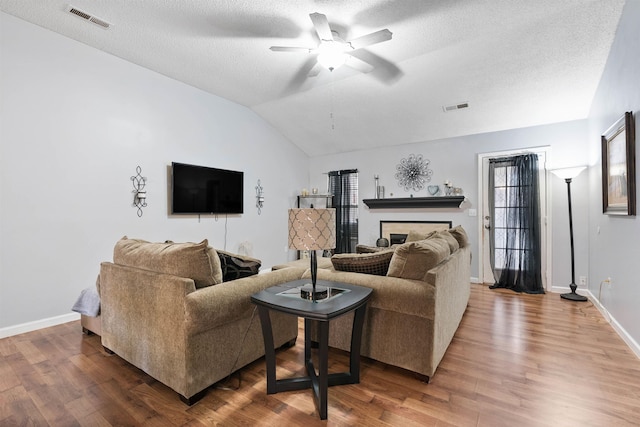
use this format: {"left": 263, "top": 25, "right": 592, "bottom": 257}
{"left": 602, "top": 112, "right": 636, "bottom": 215}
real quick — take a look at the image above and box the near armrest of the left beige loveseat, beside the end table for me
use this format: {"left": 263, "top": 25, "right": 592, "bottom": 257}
{"left": 186, "top": 268, "right": 304, "bottom": 334}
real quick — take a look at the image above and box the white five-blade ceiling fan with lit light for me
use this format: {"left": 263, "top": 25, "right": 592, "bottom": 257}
{"left": 269, "top": 12, "right": 393, "bottom": 77}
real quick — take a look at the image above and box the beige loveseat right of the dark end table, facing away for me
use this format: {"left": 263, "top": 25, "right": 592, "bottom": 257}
{"left": 278, "top": 226, "right": 471, "bottom": 381}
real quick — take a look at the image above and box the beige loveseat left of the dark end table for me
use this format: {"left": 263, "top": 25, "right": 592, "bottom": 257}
{"left": 99, "top": 237, "right": 304, "bottom": 404}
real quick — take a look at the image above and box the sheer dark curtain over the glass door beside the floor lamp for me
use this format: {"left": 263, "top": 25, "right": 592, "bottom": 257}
{"left": 489, "top": 154, "right": 544, "bottom": 294}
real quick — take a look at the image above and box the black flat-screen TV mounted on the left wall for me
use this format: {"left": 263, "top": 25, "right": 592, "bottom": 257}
{"left": 171, "top": 162, "right": 244, "bottom": 214}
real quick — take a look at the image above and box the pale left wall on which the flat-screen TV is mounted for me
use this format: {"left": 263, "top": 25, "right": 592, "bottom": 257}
{"left": 0, "top": 13, "right": 308, "bottom": 336}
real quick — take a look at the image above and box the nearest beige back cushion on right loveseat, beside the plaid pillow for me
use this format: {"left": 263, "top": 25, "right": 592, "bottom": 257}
{"left": 387, "top": 237, "right": 451, "bottom": 280}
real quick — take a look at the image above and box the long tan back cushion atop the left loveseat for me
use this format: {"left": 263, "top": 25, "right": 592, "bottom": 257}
{"left": 113, "top": 236, "right": 222, "bottom": 288}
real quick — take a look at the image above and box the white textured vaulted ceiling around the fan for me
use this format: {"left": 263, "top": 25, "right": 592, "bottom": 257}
{"left": 0, "top": 0, "right": 624, "bottom": 156}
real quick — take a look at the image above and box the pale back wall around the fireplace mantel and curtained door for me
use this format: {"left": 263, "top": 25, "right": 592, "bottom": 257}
{"left": 309, "top": 118, "right": 588, "bottom": 289}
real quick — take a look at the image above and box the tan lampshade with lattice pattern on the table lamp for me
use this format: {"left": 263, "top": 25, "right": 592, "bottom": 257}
{"left": 289, "top": 208, "right": 336, "bottom": 251}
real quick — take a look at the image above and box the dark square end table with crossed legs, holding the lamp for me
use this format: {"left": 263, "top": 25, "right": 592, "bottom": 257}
{"left": 251, "top": 279, "right": 372, "bottom": 420}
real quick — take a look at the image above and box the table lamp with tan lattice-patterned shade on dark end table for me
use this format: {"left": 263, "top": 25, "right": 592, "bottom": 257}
{"left": 289, "top": 208, "right": 336, "bottom": 301}
